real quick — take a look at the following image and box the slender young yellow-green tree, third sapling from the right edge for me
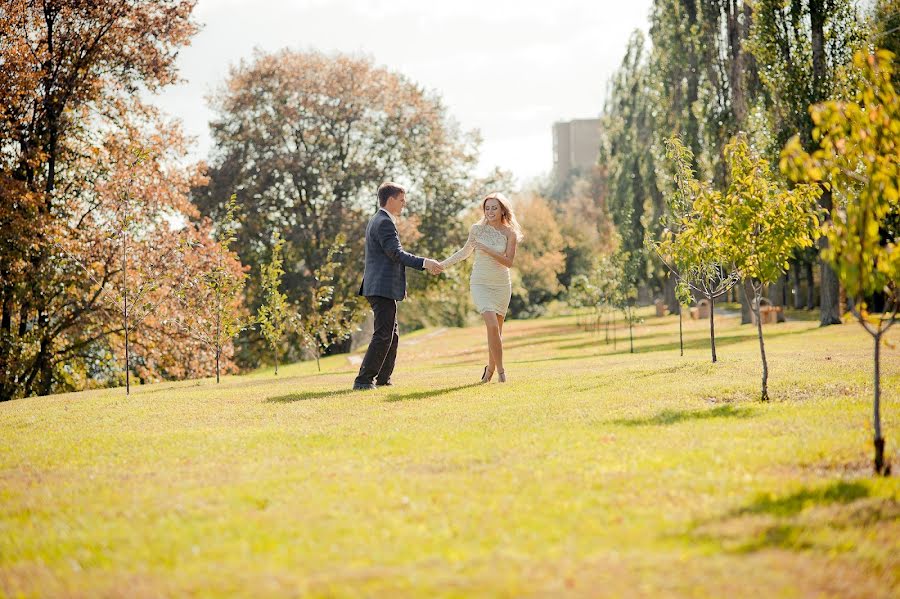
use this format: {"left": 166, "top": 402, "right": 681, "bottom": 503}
{"left": 653, "top": 137, "right": 739, "bottom": 362}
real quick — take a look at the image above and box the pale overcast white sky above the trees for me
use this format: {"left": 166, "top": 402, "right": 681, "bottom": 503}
{"left": 155, "top": 0, "right": 652, "bottom": 183}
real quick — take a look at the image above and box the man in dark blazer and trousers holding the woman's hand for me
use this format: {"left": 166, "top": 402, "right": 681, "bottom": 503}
{"left": 353, "top": 182, "right": 443, "bottom": 390}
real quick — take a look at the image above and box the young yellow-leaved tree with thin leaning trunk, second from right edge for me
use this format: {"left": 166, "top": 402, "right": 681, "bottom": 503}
{"left": 721, "top": 135, "right": 821, "bottom": 401}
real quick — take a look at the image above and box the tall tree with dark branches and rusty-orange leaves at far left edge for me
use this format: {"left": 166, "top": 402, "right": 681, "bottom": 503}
{"left": 0, "top": 0, "right": 196, "bottom": 400}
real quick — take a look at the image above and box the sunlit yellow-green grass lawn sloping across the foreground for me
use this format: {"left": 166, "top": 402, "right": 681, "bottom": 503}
{"left": 0, "top": 313, "right": 900, "bottom": 597}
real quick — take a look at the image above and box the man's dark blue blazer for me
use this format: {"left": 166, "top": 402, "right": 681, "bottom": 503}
{"left": 359, "top": 210, "right": 425, "bottom": 300}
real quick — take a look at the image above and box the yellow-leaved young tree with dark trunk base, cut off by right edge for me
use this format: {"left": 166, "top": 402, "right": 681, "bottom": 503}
{"left": 782, "top": 50, "right": 900, "bottom": 474}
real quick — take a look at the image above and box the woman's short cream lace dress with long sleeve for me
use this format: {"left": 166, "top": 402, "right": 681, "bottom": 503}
{"left": 441, "top": 224, "right": 512, "bottom": 316}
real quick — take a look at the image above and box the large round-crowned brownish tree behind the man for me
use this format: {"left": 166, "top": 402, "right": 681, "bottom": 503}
{"left": 196, "top": 50, "right": 478, "bottom": 364}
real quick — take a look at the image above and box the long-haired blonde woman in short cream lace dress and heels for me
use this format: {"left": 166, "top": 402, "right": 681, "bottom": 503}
{"left": 441, "top": 193, "right": 522, "bottom": 383}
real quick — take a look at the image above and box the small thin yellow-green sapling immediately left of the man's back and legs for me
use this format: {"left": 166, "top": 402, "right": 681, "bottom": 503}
{"left": 294, "top": 235, "right": 360, "bottom": 372}
